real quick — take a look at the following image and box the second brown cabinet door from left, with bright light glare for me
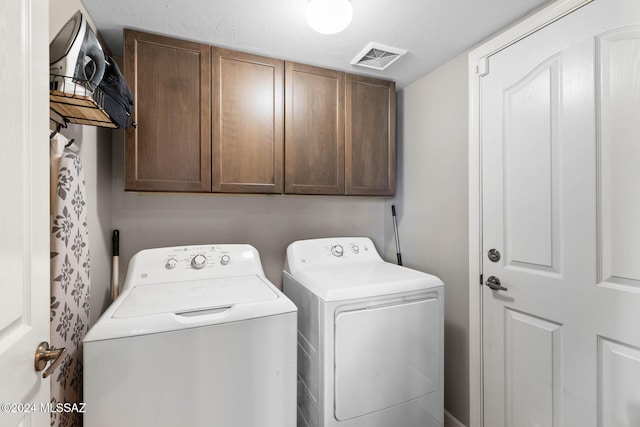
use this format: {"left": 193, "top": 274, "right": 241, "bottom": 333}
{"left": 212, "top": 48, "right": 284, "bottom": 193}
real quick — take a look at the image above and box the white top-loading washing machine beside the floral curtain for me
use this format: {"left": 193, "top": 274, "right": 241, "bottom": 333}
{"left": 84, "top": 245, "right": 297, "bottom": 427}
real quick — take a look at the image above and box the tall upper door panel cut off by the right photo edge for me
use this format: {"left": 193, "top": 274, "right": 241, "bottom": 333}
{"left": 596, "top": 26, "right": 640, "bottom": 289}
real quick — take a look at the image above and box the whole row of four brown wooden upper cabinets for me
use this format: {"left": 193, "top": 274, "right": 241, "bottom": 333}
{"left": 124, "top": 30, "right": 396, "bottom": 195}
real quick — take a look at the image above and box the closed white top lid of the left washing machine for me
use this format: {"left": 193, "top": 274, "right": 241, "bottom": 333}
{"left": 113, "top": 275, "right": 278, "bottom": 318}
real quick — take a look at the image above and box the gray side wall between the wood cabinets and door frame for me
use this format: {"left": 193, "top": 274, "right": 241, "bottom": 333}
{"left": 385, "top": 54, "right": 469, "bottom": 425}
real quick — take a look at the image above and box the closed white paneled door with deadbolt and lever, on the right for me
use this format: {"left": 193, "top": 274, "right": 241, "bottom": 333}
{"left": 481, "top": 0, "right": 640, "bottom": 427}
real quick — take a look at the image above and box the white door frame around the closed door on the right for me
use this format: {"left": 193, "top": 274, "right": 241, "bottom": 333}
{"left": 468, "top": 0, "right": 594, "bottom": 427}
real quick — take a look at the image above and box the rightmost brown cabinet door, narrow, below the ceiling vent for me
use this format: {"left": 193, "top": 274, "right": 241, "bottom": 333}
{"left": 345, "top": 75, "right": 396, "bottom": 195}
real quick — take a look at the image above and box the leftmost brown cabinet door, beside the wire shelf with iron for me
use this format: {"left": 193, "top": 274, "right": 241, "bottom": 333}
{"left": 125, "top": 30, "right": 211, "bottom": 192}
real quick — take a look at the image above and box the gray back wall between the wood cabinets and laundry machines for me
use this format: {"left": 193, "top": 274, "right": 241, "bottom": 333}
{"left": 112, "top": 133, "right": 387, "bottom": 287}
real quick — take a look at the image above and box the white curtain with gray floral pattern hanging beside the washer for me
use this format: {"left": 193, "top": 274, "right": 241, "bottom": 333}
{"left": 50, "top": 133, "right": 90, "bottom": 427}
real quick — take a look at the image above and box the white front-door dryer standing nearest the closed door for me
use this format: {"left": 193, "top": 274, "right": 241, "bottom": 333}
{"left": 283, "top": 237, "right": 444, "bottom": 427}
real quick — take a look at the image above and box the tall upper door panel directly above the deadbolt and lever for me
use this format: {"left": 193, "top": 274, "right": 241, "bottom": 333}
{"left": 503, "top": 57, "right": 560, "bottom": 271}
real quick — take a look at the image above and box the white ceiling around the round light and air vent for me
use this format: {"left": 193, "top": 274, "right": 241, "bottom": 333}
{"left": 81, "top": 0, "right": 549, "bottom": 89}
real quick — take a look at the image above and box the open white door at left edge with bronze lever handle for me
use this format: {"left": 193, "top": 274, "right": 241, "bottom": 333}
{"left": 0, "top": 0, "right": 49, "bottom": 426}
